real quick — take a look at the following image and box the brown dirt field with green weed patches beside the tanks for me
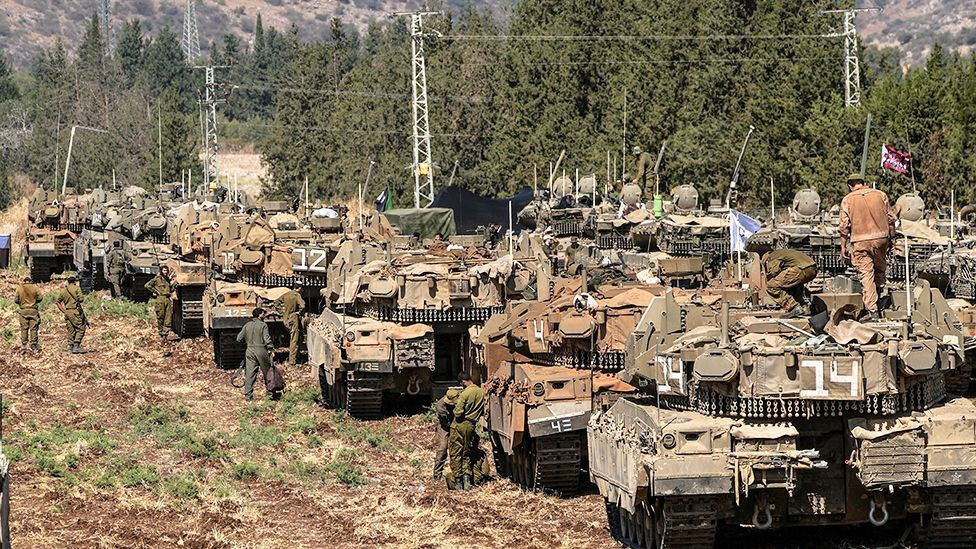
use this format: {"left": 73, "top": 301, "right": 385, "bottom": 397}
{"left": 0, "top": 272, "right": 920, "bottom": 549}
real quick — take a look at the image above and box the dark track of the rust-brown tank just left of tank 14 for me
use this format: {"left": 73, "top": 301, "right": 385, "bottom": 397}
{"left": 504, "top": 432, "right": 585, "bottom": 497}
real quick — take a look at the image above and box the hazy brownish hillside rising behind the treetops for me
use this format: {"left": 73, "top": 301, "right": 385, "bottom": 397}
{"left": 0, "top": 0, "right": 976, "bottom": 69}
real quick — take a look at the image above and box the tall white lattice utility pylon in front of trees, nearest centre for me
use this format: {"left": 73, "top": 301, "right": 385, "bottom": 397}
{"left": 390, "top": 11, "right": 443, "bottom": 208}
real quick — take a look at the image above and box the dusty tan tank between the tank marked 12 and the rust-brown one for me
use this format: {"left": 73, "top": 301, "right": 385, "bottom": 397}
{"left": 308, "top": 233, "right": 512, "bottom": 418}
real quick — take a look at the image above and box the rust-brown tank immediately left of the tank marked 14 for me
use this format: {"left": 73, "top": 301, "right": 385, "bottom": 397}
{"left": 476, "top": 279, "right": 653, "bottom": 496}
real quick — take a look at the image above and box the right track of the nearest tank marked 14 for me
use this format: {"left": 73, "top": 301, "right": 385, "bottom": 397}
{"left": 922, "top": 486, "right": 976, "bottom": 549}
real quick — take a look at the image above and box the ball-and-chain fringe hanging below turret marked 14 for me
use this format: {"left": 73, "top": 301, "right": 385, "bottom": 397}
{"left": 661, "top": 374, "right": 946, "bottom": 418}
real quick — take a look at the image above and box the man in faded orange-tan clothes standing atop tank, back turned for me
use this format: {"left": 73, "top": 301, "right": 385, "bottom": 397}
{"left": 839, "top": 174, "right": 895, "bottom": 320}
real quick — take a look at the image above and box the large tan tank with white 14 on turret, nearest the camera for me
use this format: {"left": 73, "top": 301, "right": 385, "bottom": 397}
{"left": 587, "top": 282, "right": 976, "bottom": 549}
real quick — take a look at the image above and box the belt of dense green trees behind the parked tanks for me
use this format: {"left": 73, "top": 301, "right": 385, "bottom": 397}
{"left": 0, "top": 0, "right": 976, "bottom": 211}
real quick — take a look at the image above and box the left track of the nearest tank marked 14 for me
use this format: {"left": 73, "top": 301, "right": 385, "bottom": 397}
{"left": 607, "top": 496, "right": 718, "bottom": 549}
